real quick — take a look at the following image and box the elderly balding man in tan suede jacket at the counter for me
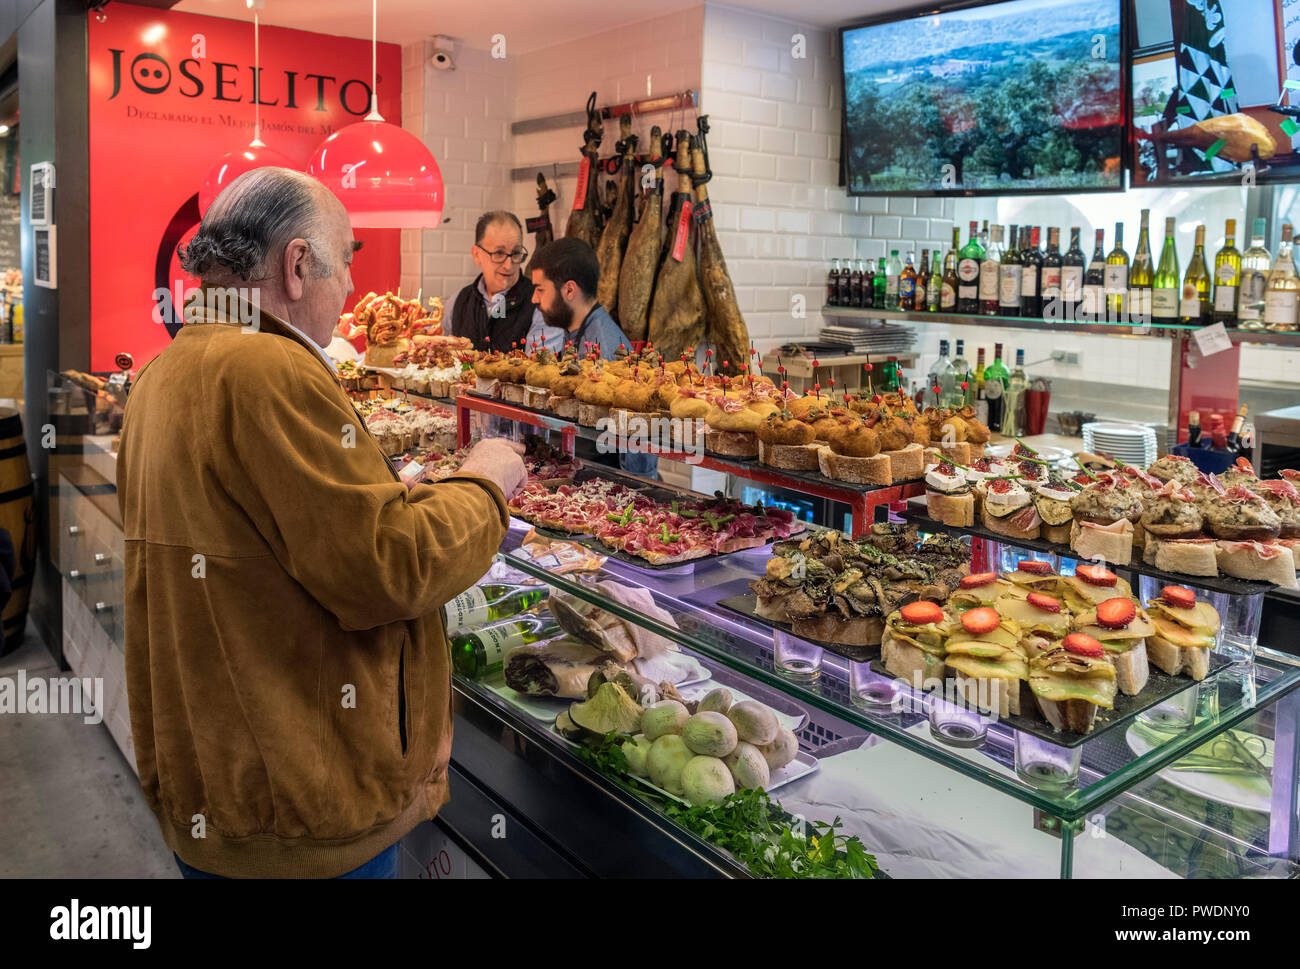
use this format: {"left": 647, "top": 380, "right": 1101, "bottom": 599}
{"left": 117, "top": 168, "right": 525, "bottom": 878}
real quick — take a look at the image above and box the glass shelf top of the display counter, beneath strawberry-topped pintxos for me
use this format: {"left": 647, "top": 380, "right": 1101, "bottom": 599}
{"left": 501, "top": 522, "right": 1300, "bottom": 822}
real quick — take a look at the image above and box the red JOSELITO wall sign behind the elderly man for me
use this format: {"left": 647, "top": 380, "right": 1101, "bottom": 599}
{"left": 87, "top": 4, "right": 402, "bottom": 371}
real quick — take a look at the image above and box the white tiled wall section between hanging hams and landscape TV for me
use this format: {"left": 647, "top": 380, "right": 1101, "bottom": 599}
{"left": 701, "top": 4, "right": 953, "bottom": 350}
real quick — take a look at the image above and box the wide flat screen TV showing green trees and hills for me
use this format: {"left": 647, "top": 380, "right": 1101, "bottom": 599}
{"left": 840, "top": 0, "right": 1127, "bottom": 195}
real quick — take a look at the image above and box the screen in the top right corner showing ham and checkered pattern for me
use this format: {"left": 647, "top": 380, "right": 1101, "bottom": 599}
{"left": 1131, "top": 0, "right": 1300, "bottom": 186}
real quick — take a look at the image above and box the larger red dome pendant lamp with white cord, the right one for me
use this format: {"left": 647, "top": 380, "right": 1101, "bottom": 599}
{"left": 307, "top": 0, "right": 443, "bottom": 229}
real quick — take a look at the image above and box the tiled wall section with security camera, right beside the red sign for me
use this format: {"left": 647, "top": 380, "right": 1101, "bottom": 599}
{"left": 402, "top": 43, "right": 515, "bottom": 301}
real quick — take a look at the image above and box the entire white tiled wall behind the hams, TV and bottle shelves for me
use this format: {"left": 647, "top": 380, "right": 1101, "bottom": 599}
{"left": 402, "top": 4, "right": 1300, "bottom": 408}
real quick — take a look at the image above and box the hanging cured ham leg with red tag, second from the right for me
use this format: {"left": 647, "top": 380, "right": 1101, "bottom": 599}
{"left": 650, "top": 130, "right": 705, "bottom": 360}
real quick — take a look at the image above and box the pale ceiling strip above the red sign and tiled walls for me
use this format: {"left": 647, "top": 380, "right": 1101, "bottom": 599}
{"left": 173, "top": 0, "right": 917, "bottom": 53}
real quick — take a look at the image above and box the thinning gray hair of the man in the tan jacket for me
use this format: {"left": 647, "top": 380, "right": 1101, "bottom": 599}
{"left": 177, "top": 168, "right": 334, "bottom": 282}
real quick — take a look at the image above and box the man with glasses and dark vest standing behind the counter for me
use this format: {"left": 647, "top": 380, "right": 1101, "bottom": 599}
{"left": 449, "top": 209, "right": 564, "bottom": 352}
